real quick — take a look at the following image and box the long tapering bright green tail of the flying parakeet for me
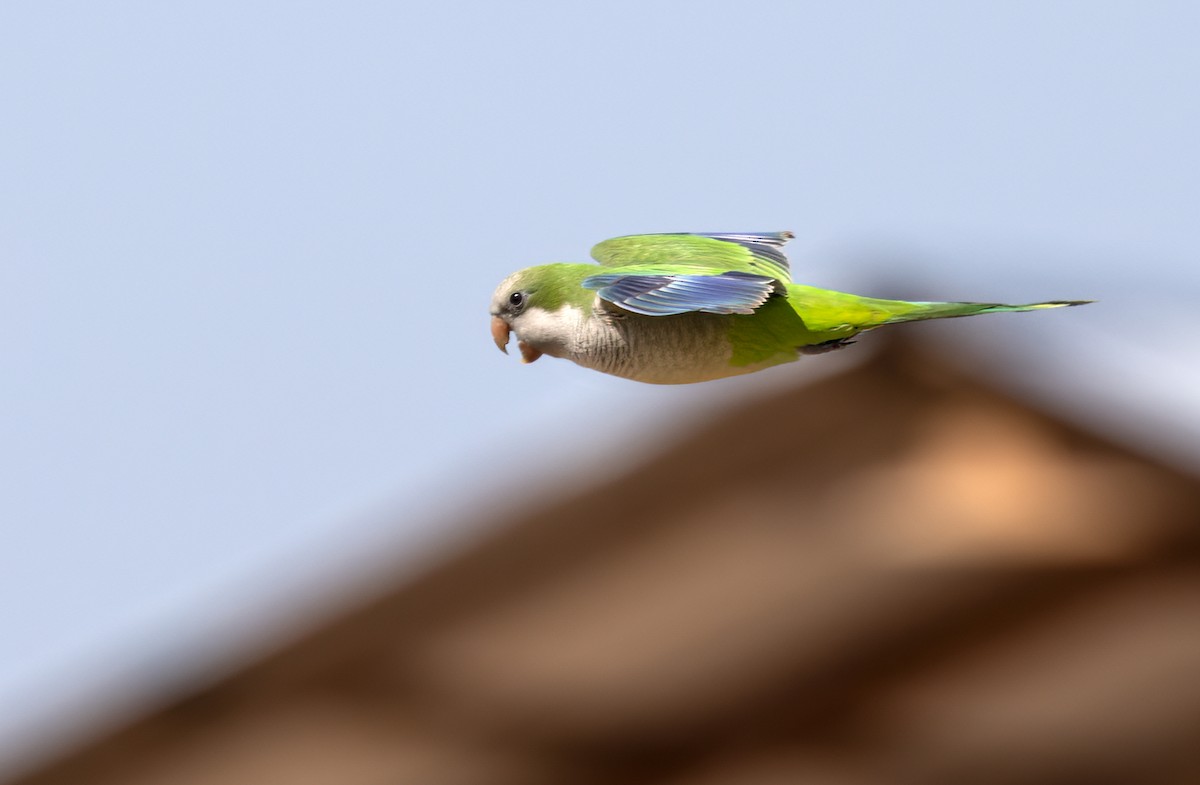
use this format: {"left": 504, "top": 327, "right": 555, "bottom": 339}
{"left": 787, "top": 283, "right": 1092, "bottom": 336}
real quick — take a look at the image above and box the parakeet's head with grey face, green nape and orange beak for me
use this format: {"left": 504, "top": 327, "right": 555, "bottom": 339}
{"left": 491, "top": 264, "right": 595, "bottom": 362}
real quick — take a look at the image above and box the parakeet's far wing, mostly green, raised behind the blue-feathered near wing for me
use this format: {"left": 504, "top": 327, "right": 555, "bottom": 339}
{"left": 592, "top": 232, "right": 793, "bottom": 284}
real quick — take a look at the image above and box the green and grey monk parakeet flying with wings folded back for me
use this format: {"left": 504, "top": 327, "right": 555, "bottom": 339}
{"left": 491, "top": 232, "right": 1087, "bottom": 384}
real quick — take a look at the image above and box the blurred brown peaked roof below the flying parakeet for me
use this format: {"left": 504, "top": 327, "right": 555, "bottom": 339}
{"left": 9, "top": 344, "right": 1200, "bottom": 785}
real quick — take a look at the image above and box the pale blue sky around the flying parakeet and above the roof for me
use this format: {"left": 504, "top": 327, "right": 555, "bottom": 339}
{"left": 0, "top": 0, "right": 1200, "bottom": 761}
